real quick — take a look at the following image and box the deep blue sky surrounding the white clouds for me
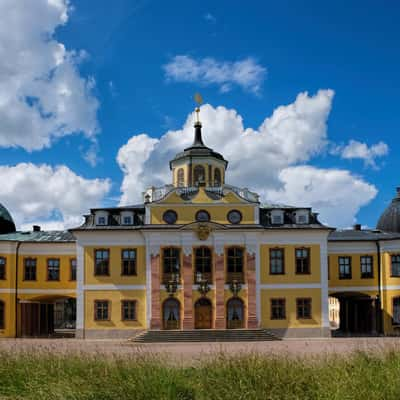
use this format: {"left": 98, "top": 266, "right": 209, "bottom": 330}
{"left": 0, "top": 0, "right": 400, "bottom": 230}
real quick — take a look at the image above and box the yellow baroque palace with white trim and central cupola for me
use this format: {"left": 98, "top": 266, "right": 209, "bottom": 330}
{"left": 0, "top": 113, "right": 400, "bottom": 338}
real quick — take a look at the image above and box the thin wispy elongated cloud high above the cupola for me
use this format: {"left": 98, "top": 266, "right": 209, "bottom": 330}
{"left": 163, "top": 55, "right": 267, "bottom": 94}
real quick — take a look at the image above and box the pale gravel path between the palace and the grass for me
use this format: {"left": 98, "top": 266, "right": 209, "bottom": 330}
{"left": 0, "top": 338, "right": 400, "bottom": 361}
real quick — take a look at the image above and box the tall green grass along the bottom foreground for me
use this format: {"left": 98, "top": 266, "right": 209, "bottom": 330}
{"left": 0, "top": 351, "right": 400, "bottom": 400}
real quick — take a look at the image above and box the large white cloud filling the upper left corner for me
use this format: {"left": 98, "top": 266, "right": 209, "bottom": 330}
{"left": 0, "top": 0, "right": 99, "bottom": 151}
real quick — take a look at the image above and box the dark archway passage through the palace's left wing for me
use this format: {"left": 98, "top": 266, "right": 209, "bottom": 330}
{"left": 17, "top": 296, "right": 76, "bottom": 338}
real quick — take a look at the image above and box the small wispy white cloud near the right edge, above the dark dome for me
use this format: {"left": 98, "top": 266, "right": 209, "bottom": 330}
{"left": 334, "top": 140, "right": 389, "bottom": 168}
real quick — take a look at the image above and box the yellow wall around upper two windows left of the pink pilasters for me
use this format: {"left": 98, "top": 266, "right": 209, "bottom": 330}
{"left": 84, "top": 246, "right": 146, "bottom": 285}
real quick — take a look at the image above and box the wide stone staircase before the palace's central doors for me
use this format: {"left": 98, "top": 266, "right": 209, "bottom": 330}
{"left": 132, "top": 329, "right": 281, "bottom": 343}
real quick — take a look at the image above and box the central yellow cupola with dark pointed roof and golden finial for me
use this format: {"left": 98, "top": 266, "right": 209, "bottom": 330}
{"left": 169, "top": 101, "right": 228, "bottom": 187}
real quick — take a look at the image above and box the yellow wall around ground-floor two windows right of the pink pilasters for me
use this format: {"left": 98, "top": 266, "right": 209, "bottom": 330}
{"left": 261, "top": 289, "right": 321, "bottom": 329}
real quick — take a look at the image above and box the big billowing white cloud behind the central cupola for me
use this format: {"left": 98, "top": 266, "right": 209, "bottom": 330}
{"left": 117, "top": 90, "right": 376, "bottom": 226}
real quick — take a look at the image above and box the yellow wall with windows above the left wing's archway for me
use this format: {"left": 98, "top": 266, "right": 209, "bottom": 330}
{"left": 18, "top": 254, "right": 76, "bottom": 289}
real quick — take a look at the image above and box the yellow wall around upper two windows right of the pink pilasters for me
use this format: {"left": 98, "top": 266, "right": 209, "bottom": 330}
{"left": 260, "top": 244, "right": 321, "bottom": 284}
